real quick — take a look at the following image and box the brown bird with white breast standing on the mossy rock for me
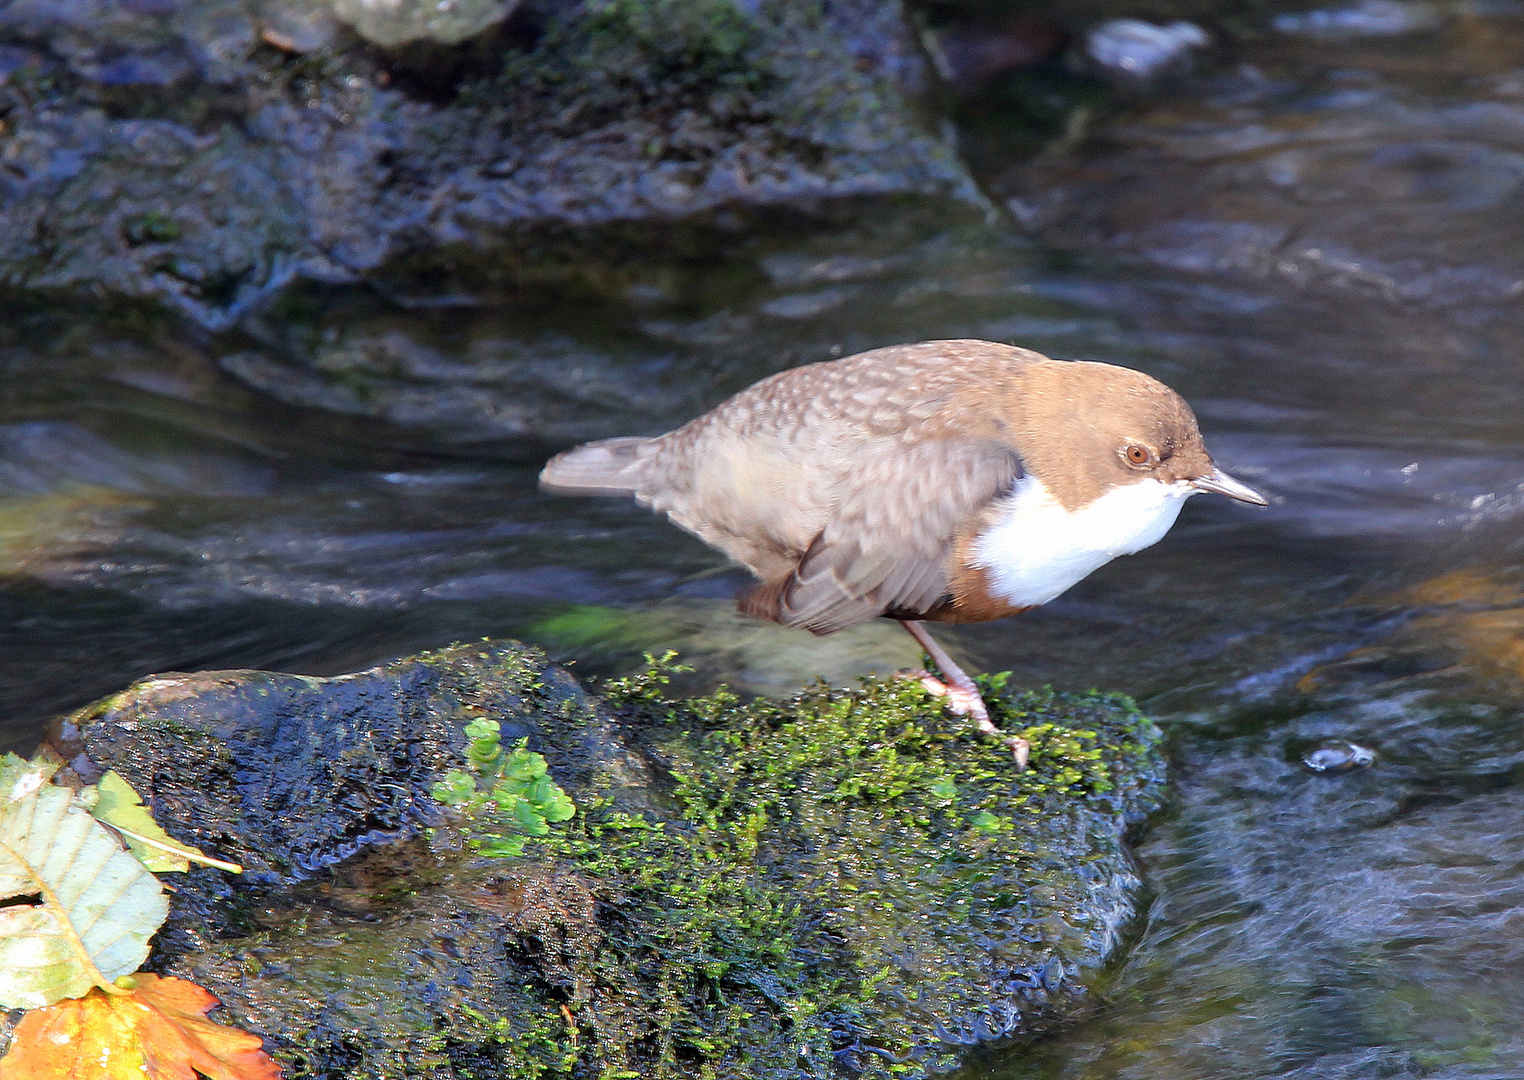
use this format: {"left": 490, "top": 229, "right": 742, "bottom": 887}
{"left": 539, "top": 340, "right": 1266, "bottom": 769}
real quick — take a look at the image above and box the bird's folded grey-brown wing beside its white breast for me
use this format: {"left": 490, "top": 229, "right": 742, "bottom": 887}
{"left": 741, "top": 439, "right": 1023, "bottom": 634}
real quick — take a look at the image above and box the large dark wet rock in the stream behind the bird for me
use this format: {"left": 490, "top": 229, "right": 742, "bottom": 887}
{"left": 0, "top": 0, "right": 978, "bottom": 328}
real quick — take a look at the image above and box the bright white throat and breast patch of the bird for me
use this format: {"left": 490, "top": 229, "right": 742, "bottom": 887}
{"left": 971, "top": 477, "right": 1195, "bottom": 608}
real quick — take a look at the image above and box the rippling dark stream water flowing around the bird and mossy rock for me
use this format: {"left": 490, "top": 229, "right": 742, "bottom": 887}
{"left": 0, "top": 2, "right": 1524, "bottom": 1080}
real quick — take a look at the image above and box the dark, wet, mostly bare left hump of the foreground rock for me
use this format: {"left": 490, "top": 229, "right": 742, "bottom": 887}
{"left": 59, "top": 639, "right": 614, "bottom": 882}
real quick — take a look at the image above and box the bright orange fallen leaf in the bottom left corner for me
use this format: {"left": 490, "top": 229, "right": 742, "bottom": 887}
{"left": 0, "top": 975, "right": 280, "bottom": 1080}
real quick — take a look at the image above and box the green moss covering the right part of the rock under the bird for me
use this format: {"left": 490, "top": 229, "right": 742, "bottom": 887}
{"left": 441, "top": 653, "right": 1160, "bottom": 1078}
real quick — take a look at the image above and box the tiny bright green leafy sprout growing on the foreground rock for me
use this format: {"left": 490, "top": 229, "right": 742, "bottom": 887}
{"left": 433, "top": 719, "right": 576, "bottom": 858}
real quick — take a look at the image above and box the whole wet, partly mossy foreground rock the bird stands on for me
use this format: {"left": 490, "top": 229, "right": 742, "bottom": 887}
{"left": 61, "top": 643, "right": 1161, "bottom": 1078}
